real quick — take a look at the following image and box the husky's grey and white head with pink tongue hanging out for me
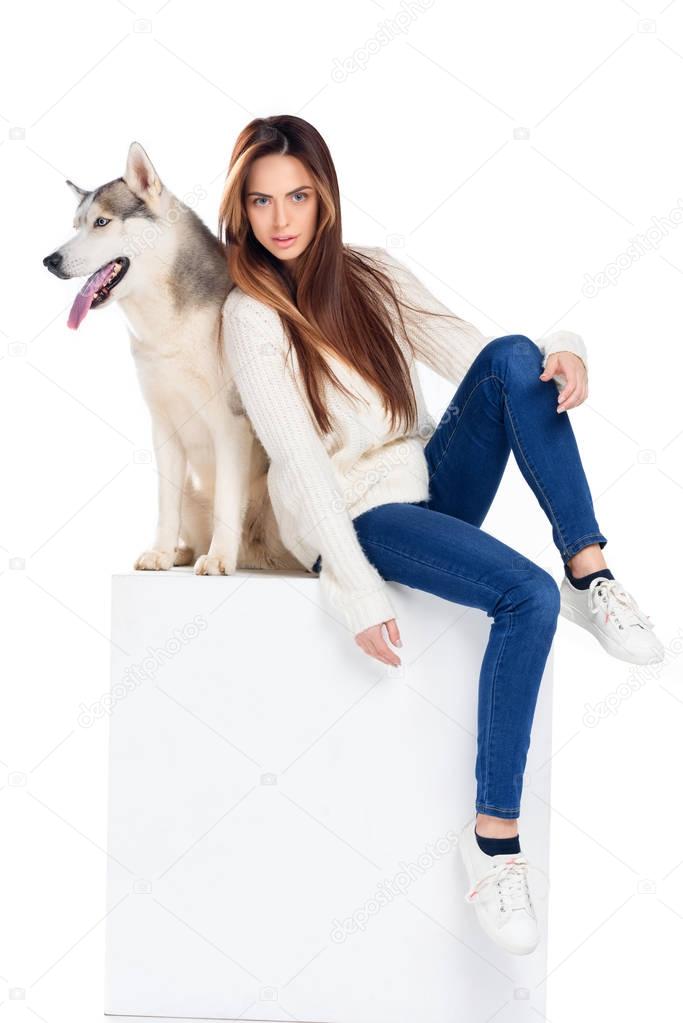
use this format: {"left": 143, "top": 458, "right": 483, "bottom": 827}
{"left": 43, "top": 142, "right": 165, "bottom": 329}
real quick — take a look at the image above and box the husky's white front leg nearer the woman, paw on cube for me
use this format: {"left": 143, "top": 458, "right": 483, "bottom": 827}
{"left": 194, "top": 416, "right": 253, "bottom": 575}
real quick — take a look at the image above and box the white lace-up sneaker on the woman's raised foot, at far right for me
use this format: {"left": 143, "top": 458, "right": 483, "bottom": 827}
{"left": 559, "top": 575, "right": 665, "bottom": 664}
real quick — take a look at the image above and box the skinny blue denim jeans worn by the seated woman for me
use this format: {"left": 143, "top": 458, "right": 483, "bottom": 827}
{"left": 314, "top": 335, "right": 607, "bottom": 818}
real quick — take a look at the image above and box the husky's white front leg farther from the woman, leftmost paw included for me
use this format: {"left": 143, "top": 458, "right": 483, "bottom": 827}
{"left": 134, "top": 409, "right": 187, "bottom": 572}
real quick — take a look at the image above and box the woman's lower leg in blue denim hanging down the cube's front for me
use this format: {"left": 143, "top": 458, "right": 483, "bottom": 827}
{"left": 354, "top": 502, "right": 559, "bottom": 822}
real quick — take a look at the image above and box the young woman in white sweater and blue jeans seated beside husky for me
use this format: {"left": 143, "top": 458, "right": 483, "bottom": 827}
{"left": 219, "top": 116, "right": 663, "bottom": 953}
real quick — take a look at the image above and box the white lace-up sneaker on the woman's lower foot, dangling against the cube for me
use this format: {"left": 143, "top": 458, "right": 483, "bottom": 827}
{"left": 458, "top": 820, "right": 539, "bottom": 955}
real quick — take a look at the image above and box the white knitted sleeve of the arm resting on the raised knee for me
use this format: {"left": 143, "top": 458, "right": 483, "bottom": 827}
{"left": 372, "top": 248, "right": 588, "bottom": 388}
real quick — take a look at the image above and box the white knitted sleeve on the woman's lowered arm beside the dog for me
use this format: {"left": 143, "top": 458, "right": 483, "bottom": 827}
{"left": 223, "top": 290, "right": 396, "bottom": 634}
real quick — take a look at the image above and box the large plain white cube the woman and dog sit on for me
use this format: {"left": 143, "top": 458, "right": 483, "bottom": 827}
{"left": 105, "top": 569, "right": 552, "bottom": 1023}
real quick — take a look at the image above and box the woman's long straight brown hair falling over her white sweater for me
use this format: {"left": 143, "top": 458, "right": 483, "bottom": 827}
{"left": 219, "top": 115, "right": 449, "bottom": 433}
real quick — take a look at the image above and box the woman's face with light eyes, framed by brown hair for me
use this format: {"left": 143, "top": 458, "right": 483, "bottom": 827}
{"left": 245, "top": 153, "right": 318, "bottom": 267}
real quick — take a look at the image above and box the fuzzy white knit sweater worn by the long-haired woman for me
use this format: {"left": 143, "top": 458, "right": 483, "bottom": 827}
{"left": 223, "top": 246, "right": 586, "bottom": 634}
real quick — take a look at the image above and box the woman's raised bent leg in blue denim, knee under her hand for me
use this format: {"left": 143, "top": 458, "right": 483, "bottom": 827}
{"left": 420, "top": 335, "right": 607, "bottom": 567}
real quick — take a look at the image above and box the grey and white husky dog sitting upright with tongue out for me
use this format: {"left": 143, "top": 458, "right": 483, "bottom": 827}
{"left": 43, "top": 142, "right": 304, "bottom": 575}
